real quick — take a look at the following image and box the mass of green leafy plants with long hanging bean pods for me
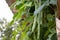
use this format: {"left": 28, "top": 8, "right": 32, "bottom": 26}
{"left": 0, "top": 0, "right": 57, "bottom": 40}
